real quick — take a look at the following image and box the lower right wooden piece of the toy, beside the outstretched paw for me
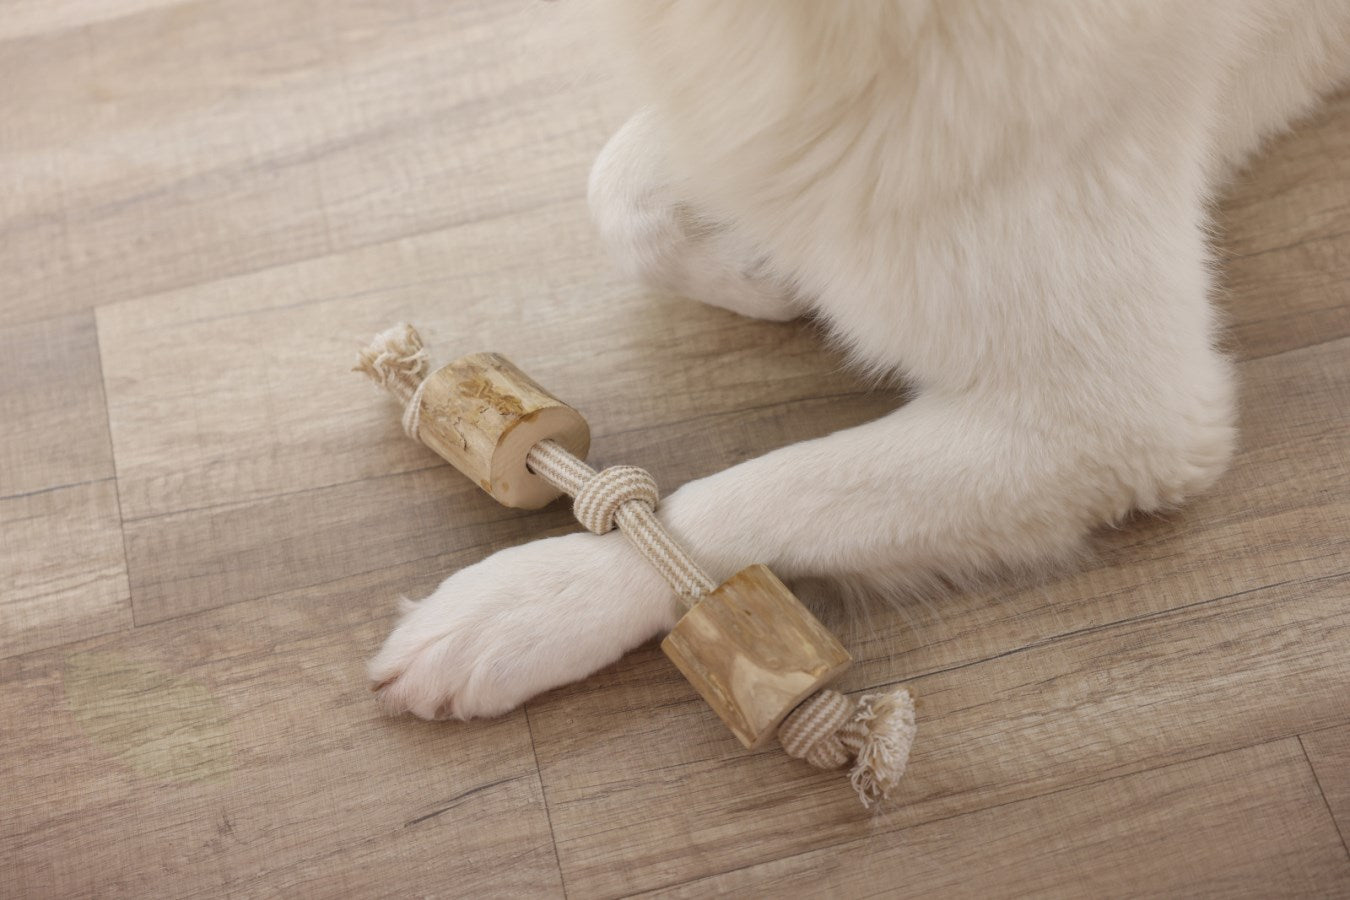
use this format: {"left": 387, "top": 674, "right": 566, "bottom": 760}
{"left": 662, "top": 565, "right": 853, "bottom": 750}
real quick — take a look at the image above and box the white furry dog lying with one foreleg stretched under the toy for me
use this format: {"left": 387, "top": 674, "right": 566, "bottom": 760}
{"left": 370, "top": 0, "right": 1350, "bottom": 718}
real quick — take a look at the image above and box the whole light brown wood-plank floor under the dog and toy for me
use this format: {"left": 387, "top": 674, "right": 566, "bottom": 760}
{"left": 0, "top": 0, "right": 1350, "bottom": 897}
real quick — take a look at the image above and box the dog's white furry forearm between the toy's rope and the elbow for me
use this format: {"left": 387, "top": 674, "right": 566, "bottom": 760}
{"left": 653, "top": 355, "right": 1234, "bottom": 601}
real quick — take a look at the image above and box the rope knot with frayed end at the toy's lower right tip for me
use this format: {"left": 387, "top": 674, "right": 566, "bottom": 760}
{"left": 778, "top": 688, "right": 915, "bottom": 807}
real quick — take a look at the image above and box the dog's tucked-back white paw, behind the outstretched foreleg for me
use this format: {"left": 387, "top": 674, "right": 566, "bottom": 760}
{"left": 589, "top": 112, "right": 802, "bottom": 321}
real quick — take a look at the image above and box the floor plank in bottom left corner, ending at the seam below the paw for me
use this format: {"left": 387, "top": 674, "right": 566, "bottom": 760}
{"left": 0, "top": 567, "right": 562, "bottom": 897}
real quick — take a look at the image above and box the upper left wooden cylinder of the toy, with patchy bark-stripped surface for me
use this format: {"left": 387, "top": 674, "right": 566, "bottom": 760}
{"left": 417, "top": 354, "right": 590, "bottom": 509}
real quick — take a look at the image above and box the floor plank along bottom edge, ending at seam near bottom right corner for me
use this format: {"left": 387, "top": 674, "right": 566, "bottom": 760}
{"left": 644, "top": 739, "right": 1350, "bottom": 897}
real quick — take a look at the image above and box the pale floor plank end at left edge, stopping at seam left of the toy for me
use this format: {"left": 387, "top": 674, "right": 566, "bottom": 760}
{"left": 0, "top": 313, "right": 131, "bottom": 656}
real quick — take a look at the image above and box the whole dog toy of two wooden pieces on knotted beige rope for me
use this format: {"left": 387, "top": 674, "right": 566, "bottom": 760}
{"left": 355, "top": 324, "right": 915, "bottom": 807}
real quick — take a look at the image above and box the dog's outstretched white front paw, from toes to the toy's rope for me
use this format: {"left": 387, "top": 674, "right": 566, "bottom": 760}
{"left": 370, "top": 533, "right": 678, "bottom": 719}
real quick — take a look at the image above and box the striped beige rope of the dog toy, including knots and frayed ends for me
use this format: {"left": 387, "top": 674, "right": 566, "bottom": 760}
{"left": 355, "top": 324, "right": 915, "bottom": 807}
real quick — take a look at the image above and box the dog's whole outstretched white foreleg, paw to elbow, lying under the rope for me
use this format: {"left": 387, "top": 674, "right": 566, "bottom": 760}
{"left": 370, "top": 345, "right": 1233, "bottom": 718}
